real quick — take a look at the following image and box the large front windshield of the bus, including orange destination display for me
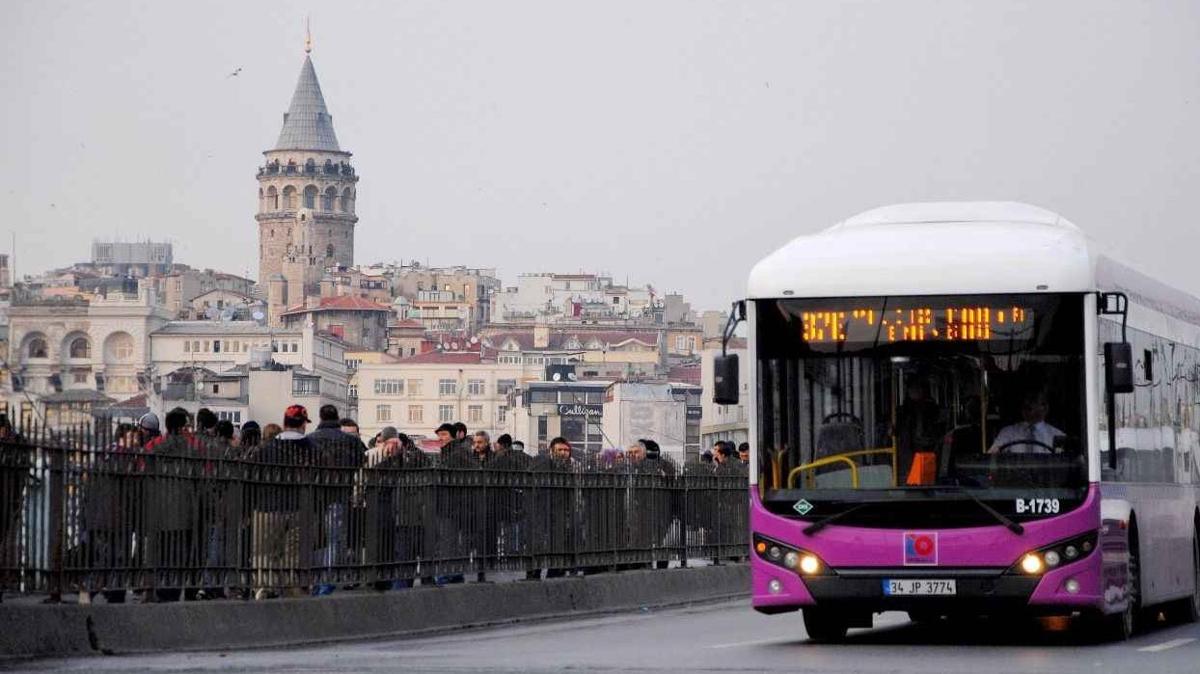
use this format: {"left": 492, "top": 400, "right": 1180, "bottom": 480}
{"left": 755, "top": 294, "right": 1087, "bottom": 516}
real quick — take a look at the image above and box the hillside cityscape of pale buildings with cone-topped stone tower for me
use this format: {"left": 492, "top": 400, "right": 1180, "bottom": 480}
{"left": 0, "top": 41, "right": 748, "bottom": 461}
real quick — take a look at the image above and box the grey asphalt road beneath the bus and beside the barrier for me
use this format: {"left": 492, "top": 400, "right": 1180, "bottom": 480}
{"left": 9, "top": 601, "right": 1200, "bottom": 674}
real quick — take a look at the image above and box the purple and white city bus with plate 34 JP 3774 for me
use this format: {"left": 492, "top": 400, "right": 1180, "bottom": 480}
{"left": 714, "top": 203, "right": 1200, "bottom": 640}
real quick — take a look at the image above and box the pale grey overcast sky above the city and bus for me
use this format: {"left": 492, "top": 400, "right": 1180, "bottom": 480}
{"left": 0, "top": 0, "right": 1200, "bottom": 308}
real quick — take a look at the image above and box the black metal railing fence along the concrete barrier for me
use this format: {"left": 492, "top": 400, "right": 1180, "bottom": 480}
{"left": 0, "top": 429, "right": 748, "bottom": 601}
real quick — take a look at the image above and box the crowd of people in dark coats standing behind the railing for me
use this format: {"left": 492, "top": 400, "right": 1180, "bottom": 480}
{"left": 0, "top": 405, "right": 748, "bottom": 602}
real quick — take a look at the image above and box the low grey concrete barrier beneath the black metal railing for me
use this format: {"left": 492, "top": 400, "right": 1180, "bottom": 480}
{"left": 0, "top": 565, "right": 750, "bottom": 657}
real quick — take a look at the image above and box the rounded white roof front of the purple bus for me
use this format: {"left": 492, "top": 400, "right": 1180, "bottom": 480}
{"left": 748, "top": 201, "right": 1094, "bottom": 299}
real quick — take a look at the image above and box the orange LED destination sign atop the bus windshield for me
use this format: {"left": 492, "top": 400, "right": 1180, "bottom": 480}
{"left": 799, "top": 303, "right": 1033, "bottom": 344}
